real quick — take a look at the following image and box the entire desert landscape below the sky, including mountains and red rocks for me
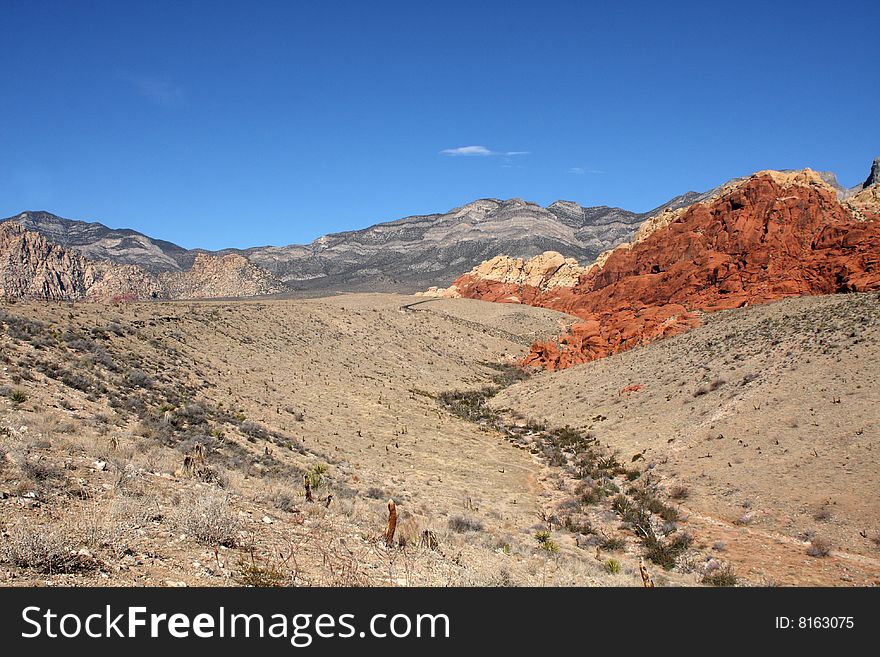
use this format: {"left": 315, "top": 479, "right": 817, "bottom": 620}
{"left": 0, "top": 159, "right": 880, "bottom": 586}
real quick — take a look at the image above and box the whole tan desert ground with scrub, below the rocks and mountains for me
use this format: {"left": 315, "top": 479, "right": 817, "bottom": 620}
{"left": 0, "top": 294, "right": 880, "bottom": 586}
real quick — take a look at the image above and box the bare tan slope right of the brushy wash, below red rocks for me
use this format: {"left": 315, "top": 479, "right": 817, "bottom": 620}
{"left": 492, "top": 293, "right": 880, "bottom": 585}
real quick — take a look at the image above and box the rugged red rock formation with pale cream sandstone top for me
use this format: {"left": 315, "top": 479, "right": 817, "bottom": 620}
{"left": 450, "top": 171, "right": 880, "bottom": 369}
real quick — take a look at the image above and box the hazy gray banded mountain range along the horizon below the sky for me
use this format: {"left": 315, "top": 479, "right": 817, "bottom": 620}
{"left": 2, "top": 192, "right": 701, "bottom": 291}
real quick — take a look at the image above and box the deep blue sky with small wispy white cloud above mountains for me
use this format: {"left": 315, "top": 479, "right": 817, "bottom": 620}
{"left": 0, "top": 0, "right": 880, "bottom": 248}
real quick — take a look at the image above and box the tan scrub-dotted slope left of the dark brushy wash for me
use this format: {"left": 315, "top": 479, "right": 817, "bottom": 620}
{"left": 0, "top": 295, "right": 680, "bottom": 585}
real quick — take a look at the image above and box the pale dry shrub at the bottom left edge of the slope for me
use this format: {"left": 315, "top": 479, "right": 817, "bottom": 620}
{"left": 2, "top": 526, "right": 96, "bottom": 574}
